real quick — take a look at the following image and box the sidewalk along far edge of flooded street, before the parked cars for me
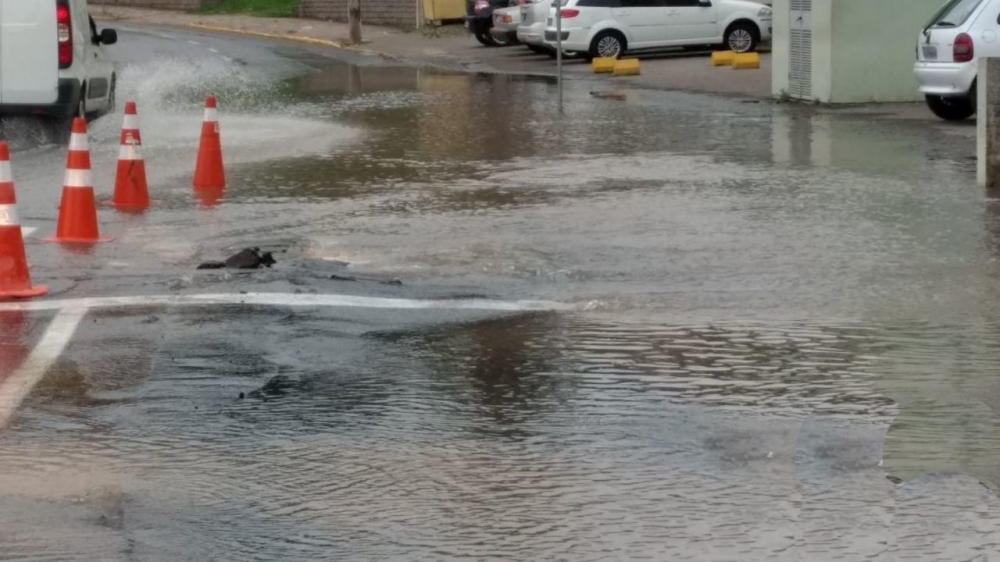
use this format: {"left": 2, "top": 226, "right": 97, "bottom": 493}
{"left": 92, "top": 6, "right": 771, "bottom": 98}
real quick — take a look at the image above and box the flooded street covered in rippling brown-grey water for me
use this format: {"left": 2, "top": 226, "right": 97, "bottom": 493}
{"left": 0, "top": 26, "right": 1000, "bottom": 562}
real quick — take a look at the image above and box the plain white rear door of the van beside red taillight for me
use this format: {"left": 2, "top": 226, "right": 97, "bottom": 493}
{"left": 0, "top": 0, "right": 59, "bottom": 105}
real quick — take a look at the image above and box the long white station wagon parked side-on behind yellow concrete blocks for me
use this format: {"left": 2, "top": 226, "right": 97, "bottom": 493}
{"left": 545, "top": 0, "right": 771, "bottom": 57}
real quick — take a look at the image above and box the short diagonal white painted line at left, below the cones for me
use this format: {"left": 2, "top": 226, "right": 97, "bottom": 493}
{"left": 0, "top": 308, "right": 87, "bottom": 428}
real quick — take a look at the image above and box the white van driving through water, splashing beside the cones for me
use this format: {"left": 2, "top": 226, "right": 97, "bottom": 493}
{"left": 0, "top": 0, "right": 118, "bottom": 123}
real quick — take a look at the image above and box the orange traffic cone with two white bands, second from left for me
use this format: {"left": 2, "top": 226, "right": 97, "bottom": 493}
{"left": 46, "top": 117, "right": 110, "bottom": 244}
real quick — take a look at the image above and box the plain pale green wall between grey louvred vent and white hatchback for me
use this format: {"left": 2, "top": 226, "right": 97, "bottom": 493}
{"left": 829, "top": 0, "right": 944, "bottom": 103}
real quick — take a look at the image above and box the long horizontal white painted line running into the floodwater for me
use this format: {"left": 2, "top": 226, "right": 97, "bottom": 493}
{"left": 0, "top": 293, "right": 572, "bottom": 312}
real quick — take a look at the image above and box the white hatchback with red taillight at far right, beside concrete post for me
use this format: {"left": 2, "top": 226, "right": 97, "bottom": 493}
{"left": 913, "top": 0, "right": 1000, "bottom": 121}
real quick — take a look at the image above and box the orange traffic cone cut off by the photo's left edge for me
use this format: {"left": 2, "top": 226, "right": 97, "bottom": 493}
{"left": 0, "top": 142, "right": 49, "bottom": 300}
